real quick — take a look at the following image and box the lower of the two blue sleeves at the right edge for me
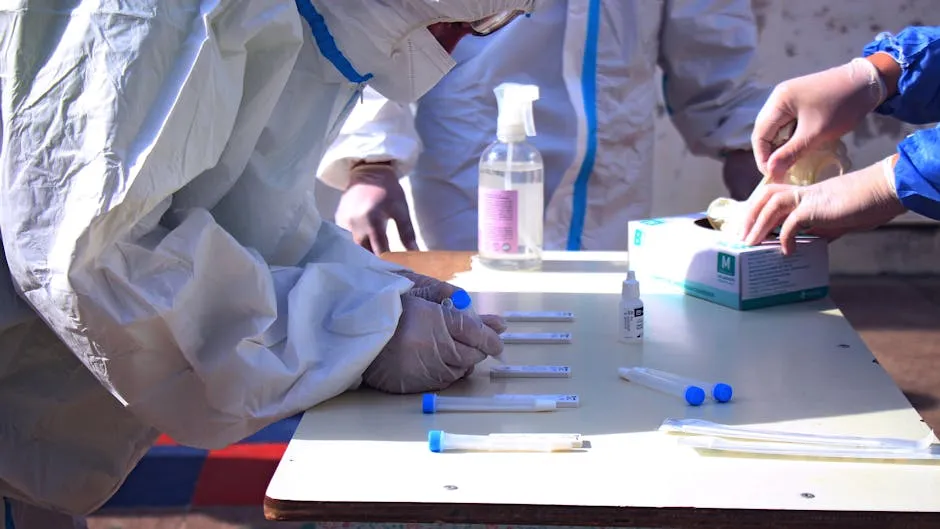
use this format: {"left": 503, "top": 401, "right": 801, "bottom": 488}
{"left": 894, "top": 128, "right": 940, "bottom": 220}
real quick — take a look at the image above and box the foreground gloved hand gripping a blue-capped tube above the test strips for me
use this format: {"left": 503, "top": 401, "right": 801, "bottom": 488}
{"left": 363, "top": 271, "right": 506, "bottom": 393}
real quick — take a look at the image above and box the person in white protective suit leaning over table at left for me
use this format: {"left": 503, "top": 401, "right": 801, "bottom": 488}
{"left": 0, "top": 0, "right": 534, "bottom": 529}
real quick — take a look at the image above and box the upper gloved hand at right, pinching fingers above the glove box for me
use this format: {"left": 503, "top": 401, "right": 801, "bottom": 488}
{"left": 751, "top": 59, "right": 885, "bottom": 183}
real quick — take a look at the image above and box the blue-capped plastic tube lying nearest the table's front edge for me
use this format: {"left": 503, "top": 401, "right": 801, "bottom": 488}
{"left": 428, "top": 430, "right": 581, "bottom": 453}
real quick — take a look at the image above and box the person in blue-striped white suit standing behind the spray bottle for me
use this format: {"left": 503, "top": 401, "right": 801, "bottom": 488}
{"left": 318, "top": 0, "right": 770, "bottom": 253}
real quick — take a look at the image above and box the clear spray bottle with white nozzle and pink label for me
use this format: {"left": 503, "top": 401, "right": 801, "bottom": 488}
{"left": 477, "top": 83, "right": 545, "bottom": 270}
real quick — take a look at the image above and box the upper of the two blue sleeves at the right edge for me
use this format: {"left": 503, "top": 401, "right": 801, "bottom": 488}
{"left": 862, "top": 26, "right": 940, "bottom": 124}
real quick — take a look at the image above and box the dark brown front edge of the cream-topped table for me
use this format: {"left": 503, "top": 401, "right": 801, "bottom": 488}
{"left": 264, "top": 496, "right": 940, "bottom": 529}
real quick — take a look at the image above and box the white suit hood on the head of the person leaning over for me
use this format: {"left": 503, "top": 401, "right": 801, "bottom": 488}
{"left": 312, "top": 0, "right": 535, "bottom": 103}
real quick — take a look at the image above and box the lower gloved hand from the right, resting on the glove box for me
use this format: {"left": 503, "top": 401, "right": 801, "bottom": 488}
{"left": 742, "top": 156, "right": 906, "bottom": 254}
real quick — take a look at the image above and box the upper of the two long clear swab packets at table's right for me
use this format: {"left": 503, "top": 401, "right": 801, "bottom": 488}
{"left": 659, "top": 419, "right": 933, "bottom": 451}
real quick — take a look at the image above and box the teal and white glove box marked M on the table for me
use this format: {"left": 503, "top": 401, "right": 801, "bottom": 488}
{"left": 628, "top": 213, "right": 829, "bottom": 310}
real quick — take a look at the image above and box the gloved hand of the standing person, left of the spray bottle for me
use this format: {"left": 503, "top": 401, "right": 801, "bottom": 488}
{"left": 335, "top": 163, "right": 418, "bottom": 255}
